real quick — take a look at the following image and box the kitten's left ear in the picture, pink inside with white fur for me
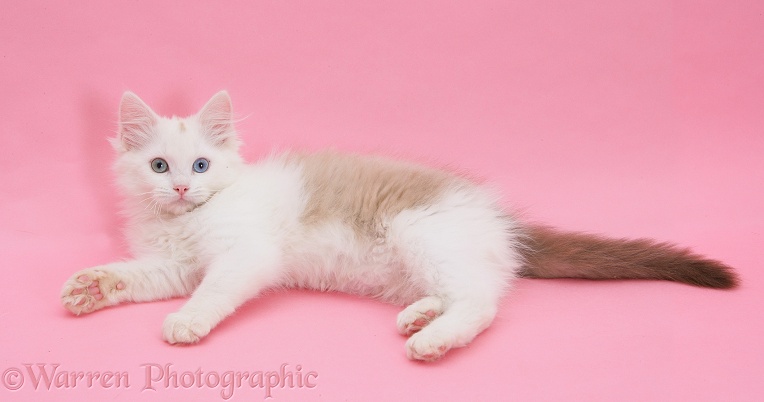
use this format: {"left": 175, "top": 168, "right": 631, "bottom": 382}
{"left": 114, "top": 91, "right": 158, "bottom": 151}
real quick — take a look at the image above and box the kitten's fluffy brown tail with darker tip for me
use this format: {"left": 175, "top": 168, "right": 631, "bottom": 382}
{"left": 521, "top": 226, "right": 738, "bottom": 289}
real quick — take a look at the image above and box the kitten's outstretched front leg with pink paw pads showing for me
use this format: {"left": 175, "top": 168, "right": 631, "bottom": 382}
{"left": 61, "top": 259, "right": 198, "bottom": 315}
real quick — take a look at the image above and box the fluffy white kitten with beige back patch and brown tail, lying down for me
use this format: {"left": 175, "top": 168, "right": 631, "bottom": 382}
{"left": 61, "top": 92, "right": 737, "bottom": 361}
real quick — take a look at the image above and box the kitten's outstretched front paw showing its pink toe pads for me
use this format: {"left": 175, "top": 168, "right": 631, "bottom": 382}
{"left": 61, "top": 268, "right": 125, "bottom": 315}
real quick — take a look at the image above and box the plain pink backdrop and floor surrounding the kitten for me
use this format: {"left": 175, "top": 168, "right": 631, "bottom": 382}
{"left": 0, "top": 0, "right": 764, "bottom": 401}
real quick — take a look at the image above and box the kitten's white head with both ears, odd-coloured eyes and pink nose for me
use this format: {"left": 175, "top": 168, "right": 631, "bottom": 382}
{"left": 112, "top": 92, "right": 242, "bottom": 215}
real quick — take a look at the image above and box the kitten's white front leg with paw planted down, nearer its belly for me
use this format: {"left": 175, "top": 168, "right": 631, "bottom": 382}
{"left": 162, "top": 249, "right": 278, "bottom": 344}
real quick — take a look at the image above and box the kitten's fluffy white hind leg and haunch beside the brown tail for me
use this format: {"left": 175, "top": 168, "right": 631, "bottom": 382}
{"left": 390, "top": 195, "right": 519, "bottom": 361}
